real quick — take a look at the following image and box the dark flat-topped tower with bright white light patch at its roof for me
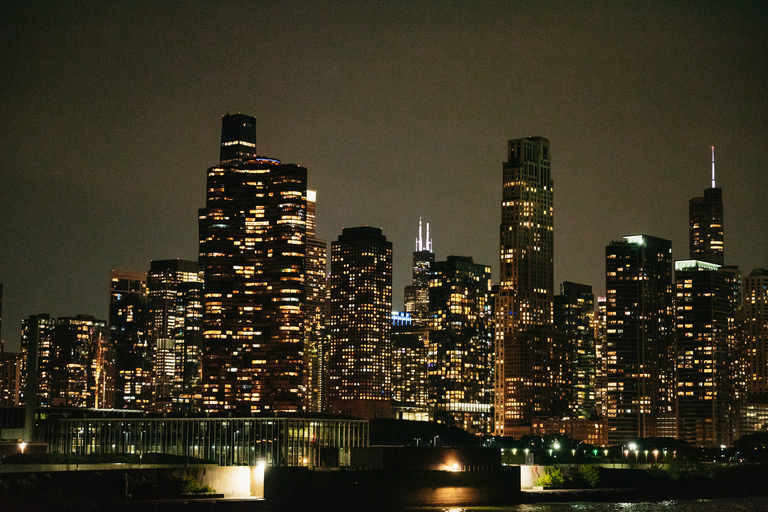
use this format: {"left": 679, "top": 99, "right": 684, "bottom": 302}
{"left": 604, "top": 235, "right": 676, "bottom": 444}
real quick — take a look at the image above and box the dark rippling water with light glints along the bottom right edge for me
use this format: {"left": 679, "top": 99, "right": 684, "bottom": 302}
{"left": 414, "top": 497, "right": 768, "bottom": 512}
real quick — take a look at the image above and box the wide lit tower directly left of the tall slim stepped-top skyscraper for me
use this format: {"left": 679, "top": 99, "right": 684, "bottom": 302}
{"left": 428, "top": 256, "right": 494, "bottom": 435}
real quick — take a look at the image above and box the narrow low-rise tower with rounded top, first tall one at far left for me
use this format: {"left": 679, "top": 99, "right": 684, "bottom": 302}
{"left": 21, "top": 314, "right": 56, "bottom": 407}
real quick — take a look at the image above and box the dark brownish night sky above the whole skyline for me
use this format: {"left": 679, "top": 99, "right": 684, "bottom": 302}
{"left": 0, "top": 0, "right": 768, "bottom": 349}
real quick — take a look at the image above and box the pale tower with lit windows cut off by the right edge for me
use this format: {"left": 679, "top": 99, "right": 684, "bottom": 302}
{"left": 740, "top": 268, "right": 768, "bottom": 435}
